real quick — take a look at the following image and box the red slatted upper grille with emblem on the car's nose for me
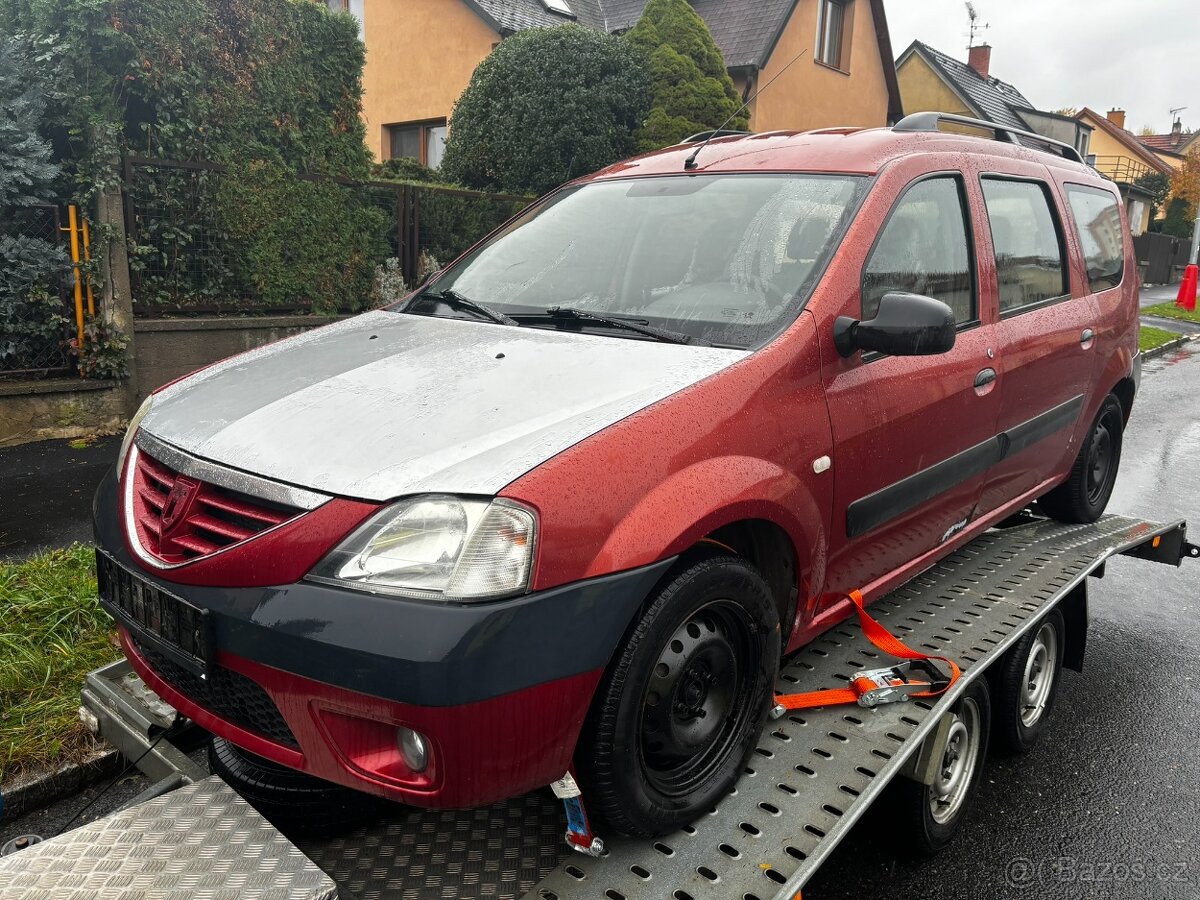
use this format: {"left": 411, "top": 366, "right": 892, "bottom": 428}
{"left": 130, "top": 451, "right": 304, "bottom": 564}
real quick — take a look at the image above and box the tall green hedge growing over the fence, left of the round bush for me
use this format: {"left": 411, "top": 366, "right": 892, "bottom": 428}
{"left": 0, "top": 0, "right": 386, "bottom": 312}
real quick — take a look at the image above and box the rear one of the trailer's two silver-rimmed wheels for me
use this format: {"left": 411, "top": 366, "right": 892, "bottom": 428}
{"left": 995, "top": 610, "right": 1066, "bottom": 754}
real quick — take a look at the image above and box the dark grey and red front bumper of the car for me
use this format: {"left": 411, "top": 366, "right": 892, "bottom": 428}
{"left": 95, "top": 473, "right": 672, "bottom": 808}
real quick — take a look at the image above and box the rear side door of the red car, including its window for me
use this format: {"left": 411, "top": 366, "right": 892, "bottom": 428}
{"left": 979, "top": 160, "right": 1097, "bottom": 512}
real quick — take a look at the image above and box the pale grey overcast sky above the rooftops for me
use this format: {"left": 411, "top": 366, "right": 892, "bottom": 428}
{"left": 884, "top": 0, "right": 1200, "bottom": 133}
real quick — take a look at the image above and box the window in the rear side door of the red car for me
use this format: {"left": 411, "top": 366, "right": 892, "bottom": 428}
{"left": 983, "top": 178, "right": 1070, "bottom": 314}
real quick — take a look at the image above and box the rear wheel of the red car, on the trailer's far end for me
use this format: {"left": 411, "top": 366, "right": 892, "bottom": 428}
{"left": 1038, "top": 394, "right": 1124, "bottom": 523}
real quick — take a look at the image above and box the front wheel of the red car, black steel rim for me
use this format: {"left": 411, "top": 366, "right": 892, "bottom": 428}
{"left": 576, "top": 556, "right": 780, "bottom": 838}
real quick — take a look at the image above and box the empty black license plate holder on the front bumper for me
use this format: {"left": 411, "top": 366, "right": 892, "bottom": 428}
{"left": 96, "top": 548, "right": 212, "bottom": 678}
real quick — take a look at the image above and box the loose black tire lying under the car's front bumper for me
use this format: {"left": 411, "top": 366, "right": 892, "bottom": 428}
{"left": 209, "top": 737, "right": 390, "bottom": 834}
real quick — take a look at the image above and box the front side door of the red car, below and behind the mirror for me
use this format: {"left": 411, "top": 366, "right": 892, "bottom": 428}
{"left": 810, "top": 156, "right": 1000, "bottom": 616}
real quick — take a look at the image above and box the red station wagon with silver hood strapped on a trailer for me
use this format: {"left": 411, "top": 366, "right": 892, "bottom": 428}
{"left": 95, "top": 114, "right": 1139, "bottom": 835}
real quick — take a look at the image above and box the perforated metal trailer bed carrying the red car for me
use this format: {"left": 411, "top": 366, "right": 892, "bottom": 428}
{"left": 0, "top": 516, "right": 1200, "bottom": 900}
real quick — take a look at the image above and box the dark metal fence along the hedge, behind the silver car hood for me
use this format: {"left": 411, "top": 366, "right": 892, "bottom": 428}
{"left": 124, "top": 156, "right": 529, "bottom": 317}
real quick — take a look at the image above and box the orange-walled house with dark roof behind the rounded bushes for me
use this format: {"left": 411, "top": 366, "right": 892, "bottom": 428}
{"left": 325, "top": 0, "right": 902, "bottom": 168}
